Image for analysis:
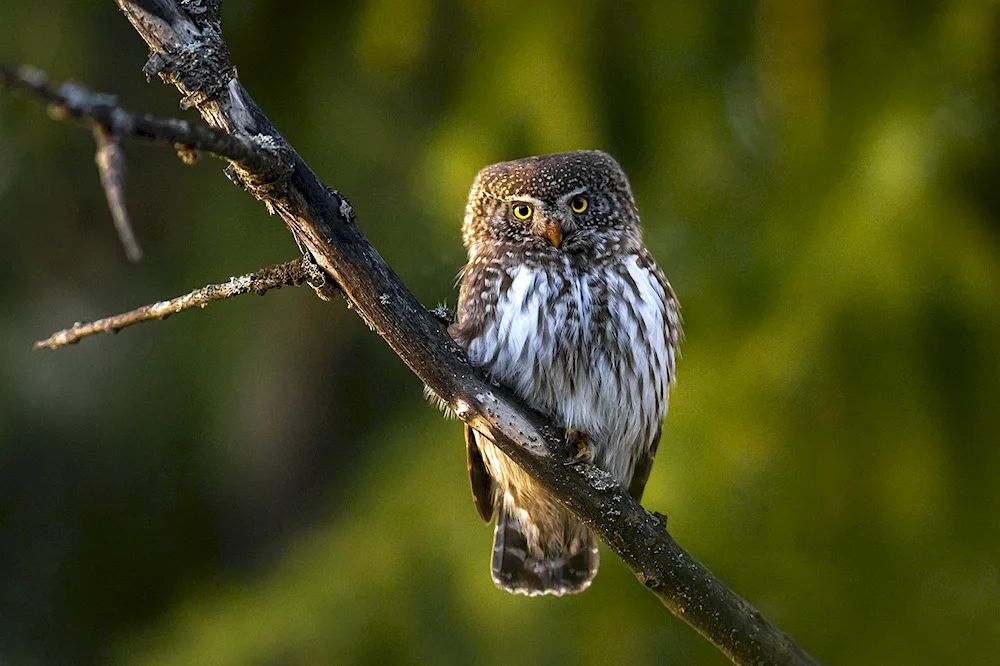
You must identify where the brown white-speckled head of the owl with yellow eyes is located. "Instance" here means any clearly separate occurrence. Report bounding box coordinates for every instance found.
[462,150,641,258]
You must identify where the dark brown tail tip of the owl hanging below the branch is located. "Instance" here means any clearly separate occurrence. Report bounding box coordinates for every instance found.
[492,507,600,597]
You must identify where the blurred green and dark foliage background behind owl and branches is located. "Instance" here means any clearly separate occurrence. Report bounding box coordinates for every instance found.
[0,0,1000,666]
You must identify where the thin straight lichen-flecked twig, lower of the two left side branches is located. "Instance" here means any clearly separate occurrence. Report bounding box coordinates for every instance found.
[35,259,324,349]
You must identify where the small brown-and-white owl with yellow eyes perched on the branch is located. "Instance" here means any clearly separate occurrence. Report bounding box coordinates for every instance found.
[449,151,681,596]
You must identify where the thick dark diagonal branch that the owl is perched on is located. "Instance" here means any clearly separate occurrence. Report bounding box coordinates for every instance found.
[5,0,817,664]
